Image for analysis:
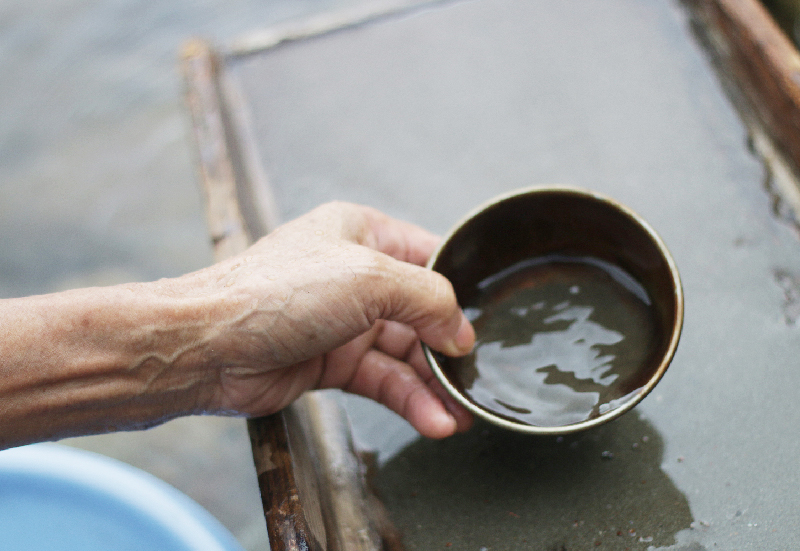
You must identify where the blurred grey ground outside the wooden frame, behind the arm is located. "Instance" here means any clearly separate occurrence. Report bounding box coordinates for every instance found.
[0,0,360,549]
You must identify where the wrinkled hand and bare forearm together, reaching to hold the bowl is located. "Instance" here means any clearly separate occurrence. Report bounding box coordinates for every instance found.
[0,203,475,446]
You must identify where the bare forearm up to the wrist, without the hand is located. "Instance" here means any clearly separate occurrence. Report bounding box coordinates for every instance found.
[0,280,218,447]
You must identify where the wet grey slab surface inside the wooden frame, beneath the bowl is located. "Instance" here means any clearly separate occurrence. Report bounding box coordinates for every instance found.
[223,0,800,551]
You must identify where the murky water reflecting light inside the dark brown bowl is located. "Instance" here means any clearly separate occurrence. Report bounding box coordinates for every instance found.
[451,256,658,426]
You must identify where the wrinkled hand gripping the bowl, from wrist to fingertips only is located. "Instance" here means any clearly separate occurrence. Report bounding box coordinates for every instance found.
[206,203,475,438]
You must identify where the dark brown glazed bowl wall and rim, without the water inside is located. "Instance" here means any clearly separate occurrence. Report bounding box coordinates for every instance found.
[425,187,683,434]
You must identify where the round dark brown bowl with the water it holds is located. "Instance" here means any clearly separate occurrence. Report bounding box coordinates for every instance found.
[425,187,683,434]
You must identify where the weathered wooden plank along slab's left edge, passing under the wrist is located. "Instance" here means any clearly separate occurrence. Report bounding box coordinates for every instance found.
[182,41,388,551]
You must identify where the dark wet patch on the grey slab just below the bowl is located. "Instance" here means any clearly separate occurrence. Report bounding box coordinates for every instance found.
[376,411,702,551]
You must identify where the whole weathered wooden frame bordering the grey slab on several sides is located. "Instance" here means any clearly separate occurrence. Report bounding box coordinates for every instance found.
[182,0,800,551]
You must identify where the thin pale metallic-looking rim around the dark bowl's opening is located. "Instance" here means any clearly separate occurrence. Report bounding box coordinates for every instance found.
[422,185,684,436]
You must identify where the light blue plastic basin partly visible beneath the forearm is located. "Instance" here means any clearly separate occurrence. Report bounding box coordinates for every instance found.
[0,444,242,551]
